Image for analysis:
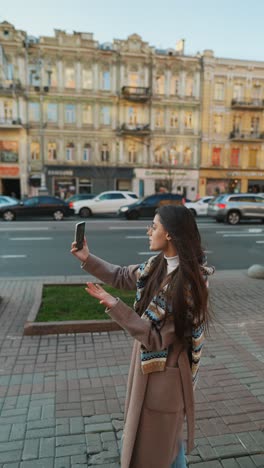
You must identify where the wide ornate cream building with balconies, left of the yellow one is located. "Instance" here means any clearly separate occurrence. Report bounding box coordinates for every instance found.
[0,22,201,198]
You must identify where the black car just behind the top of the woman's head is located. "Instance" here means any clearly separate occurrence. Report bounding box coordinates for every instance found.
[118,193,186,219]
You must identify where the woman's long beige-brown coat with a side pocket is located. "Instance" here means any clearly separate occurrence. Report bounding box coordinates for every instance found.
[82,254,194,468]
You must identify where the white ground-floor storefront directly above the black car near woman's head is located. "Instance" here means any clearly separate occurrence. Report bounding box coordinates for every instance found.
[133,169,199,200]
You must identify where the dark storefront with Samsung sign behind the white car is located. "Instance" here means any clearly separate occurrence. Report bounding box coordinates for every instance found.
[47,166,133,199]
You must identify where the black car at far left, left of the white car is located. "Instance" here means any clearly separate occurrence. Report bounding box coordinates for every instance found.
[0,195,74,221]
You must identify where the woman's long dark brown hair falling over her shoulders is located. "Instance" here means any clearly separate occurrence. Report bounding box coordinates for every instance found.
[137,205,209,342]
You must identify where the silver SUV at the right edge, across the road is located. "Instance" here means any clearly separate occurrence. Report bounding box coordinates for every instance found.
[208,193,264,224]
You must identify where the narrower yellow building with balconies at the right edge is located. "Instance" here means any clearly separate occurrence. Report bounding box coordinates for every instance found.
[199,50,264,196]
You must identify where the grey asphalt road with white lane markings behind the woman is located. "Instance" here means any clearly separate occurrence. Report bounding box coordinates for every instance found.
[0,218,264,277]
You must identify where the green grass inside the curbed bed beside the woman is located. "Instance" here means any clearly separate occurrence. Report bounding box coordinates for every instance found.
[36,285,135,322]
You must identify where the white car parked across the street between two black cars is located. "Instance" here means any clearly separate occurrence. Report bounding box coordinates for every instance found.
[69,190,138,218]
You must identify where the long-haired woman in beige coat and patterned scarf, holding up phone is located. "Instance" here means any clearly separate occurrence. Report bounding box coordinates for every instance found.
[71,205,214,468]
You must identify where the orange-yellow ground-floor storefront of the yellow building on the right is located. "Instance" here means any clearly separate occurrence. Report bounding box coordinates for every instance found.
[199,169,264,196]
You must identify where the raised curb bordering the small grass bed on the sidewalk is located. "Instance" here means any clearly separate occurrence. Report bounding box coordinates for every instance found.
[23,281,122,336]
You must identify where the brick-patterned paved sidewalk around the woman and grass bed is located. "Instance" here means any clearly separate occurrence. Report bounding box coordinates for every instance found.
[0,272,264,468]
